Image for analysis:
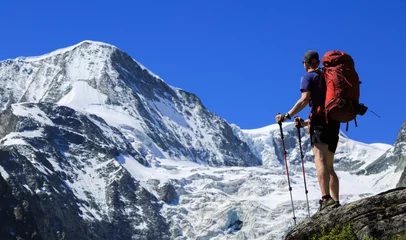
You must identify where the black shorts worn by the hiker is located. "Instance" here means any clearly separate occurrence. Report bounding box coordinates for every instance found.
[310,117,340,153]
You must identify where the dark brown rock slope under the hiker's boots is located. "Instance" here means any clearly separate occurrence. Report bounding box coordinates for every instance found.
[285,188,406,240]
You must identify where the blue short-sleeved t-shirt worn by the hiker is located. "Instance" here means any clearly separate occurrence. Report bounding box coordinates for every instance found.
[300,72,326,107]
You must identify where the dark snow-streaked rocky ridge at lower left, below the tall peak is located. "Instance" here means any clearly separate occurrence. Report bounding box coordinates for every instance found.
[0,103,170,239]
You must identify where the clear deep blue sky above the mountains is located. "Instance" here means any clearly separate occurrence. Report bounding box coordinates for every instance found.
[0,0,406,144]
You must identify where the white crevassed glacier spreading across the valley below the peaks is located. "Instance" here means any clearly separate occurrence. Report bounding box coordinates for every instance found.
[116,153,401,240]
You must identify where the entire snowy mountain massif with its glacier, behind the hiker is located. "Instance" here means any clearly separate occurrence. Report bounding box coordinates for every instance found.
[0,41,401,240]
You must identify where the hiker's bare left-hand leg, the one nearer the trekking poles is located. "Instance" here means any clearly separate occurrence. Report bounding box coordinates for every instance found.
[312,143,330,196]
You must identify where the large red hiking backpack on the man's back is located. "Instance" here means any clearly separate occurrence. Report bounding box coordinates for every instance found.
[321,50,368,130]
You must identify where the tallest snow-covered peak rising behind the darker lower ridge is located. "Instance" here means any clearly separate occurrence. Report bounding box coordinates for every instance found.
[0,41,260,166]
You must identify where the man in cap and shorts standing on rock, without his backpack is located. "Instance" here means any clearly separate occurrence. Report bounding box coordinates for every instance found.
[275,50,340,211]
